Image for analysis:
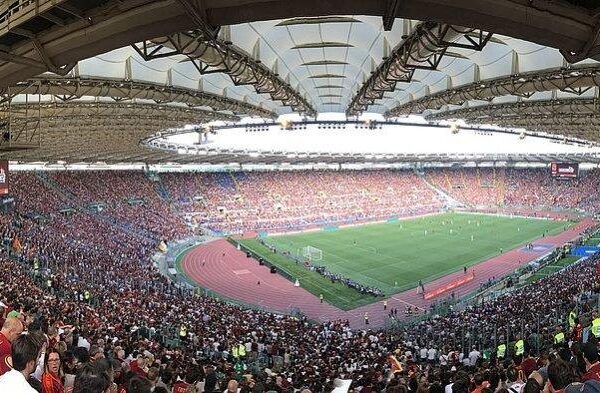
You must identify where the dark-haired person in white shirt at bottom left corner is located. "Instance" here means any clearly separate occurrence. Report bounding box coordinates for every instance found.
[0,334,40,393]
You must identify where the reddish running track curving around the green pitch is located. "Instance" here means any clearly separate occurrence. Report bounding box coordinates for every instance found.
[182,219,595,328]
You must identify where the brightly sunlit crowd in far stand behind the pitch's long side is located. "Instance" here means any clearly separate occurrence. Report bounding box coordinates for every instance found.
[163,170,442,232]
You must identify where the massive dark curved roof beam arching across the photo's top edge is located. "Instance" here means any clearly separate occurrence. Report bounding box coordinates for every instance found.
[0,0,600,93]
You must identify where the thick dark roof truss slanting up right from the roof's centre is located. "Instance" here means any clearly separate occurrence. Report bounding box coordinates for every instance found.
[346,22,492,116]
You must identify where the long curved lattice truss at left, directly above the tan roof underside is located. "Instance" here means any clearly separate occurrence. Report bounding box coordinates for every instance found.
[0,76,277,118]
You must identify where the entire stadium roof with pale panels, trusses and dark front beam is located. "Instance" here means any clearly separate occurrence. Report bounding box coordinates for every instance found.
[0,0,600,162]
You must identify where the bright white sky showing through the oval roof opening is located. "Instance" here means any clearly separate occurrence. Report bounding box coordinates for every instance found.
[146,121,600,163]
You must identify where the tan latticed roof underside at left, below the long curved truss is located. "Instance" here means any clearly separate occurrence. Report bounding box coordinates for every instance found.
[0,99,238,157]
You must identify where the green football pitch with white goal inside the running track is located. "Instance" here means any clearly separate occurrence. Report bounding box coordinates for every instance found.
[241,213,573,310]
